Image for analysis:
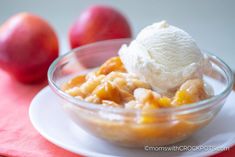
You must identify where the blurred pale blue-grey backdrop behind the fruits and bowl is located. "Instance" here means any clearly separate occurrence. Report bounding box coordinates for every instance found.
[0,0,235,71]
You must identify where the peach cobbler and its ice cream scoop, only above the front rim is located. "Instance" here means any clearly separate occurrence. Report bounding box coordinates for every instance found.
[62,21,210,110]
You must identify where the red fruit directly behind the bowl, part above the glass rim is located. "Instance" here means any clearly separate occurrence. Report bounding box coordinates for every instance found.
[69,5,132,48]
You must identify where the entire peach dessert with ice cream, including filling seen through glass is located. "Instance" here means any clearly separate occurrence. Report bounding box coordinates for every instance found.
[61,21,214,147]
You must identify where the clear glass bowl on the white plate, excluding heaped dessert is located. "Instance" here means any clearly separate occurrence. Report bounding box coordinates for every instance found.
[48,39,233,147]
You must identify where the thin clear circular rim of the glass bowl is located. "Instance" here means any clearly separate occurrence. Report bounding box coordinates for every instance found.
[47,38,234,114]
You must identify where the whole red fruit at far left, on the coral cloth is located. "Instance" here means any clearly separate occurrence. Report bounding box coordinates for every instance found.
[0,13,59,83]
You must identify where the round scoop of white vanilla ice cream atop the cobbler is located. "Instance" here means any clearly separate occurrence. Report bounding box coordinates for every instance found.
[119,21,207,95]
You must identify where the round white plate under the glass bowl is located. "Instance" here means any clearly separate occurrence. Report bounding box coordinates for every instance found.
[29,87,235,157]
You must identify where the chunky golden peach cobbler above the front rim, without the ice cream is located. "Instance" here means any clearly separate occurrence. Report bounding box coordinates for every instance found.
[62,57,209,110]
